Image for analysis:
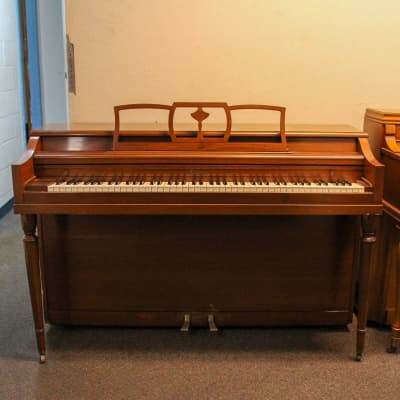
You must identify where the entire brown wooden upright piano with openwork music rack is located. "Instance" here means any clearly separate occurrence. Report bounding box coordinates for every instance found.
[13,102,383,362]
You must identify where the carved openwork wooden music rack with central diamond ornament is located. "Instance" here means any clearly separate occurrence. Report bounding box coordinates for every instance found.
[113,102,287,151]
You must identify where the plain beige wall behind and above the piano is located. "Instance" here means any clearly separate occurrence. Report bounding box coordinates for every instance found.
[66,0,400,127]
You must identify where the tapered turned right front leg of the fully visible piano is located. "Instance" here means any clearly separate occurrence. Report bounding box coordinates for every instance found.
[356,214,378,361]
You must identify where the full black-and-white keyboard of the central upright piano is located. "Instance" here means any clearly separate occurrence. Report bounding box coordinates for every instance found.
[48,178,366,193]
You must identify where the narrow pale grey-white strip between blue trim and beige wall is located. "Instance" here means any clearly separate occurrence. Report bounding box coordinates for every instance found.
[37,0,69,124]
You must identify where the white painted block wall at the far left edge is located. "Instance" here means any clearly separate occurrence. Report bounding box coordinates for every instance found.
[0,0,24,207]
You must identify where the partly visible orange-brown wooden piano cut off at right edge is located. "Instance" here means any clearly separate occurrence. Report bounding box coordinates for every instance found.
[364,109,400,352]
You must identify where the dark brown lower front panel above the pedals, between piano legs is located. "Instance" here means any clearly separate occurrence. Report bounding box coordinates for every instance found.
[40,215,358,326]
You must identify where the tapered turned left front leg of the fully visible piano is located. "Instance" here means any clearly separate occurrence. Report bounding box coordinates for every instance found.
[21,215,46,363]
